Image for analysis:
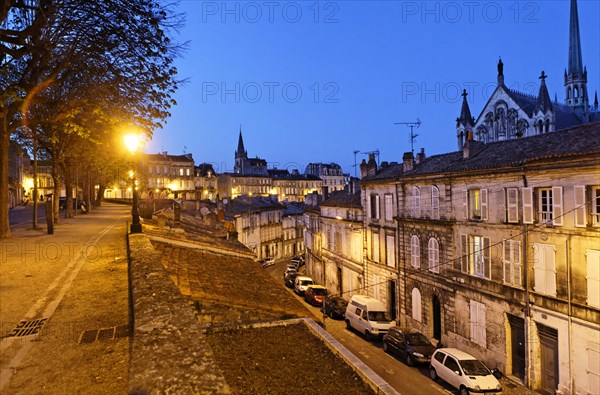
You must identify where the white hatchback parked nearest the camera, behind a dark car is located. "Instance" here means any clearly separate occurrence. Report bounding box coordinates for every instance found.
[429,348,502,395]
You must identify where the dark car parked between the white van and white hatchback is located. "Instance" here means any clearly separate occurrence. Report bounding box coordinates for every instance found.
[383,326,435,366]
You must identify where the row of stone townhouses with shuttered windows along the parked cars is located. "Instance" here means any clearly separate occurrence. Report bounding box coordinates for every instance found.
[306,123,600,394]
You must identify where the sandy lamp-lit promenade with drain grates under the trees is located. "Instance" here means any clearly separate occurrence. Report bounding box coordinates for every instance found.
[0,203,129,394]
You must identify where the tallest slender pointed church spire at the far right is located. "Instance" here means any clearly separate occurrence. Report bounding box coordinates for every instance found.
[565,0,589,117]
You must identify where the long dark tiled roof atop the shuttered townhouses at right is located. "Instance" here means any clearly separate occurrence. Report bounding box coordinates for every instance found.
[361,122,600,182]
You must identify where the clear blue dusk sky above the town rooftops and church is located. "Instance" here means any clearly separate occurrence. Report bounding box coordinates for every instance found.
[146,0,600,175]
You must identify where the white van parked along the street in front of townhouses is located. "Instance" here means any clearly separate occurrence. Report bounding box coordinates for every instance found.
[345,295,396,340]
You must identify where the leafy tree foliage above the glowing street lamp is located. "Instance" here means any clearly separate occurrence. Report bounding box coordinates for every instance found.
[0,0,182,238]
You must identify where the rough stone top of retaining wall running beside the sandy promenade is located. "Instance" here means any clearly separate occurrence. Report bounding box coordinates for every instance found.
[129,234,230,394]
